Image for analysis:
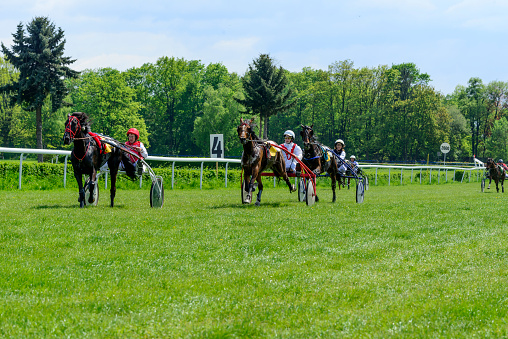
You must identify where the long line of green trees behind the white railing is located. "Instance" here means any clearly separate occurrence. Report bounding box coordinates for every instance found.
[0,18,508,162]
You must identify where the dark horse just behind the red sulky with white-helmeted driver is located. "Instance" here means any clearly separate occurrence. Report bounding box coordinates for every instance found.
[300,125,340,202]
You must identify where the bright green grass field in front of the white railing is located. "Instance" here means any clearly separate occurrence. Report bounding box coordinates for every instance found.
[0,183,508,338]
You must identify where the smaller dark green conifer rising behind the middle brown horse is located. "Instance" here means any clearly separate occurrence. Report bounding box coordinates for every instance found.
[236,54,296,138]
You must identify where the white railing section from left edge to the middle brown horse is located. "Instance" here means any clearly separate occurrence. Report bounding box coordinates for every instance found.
[0,147,240,189]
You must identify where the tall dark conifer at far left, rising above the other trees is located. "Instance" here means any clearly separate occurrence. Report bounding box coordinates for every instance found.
[0,17,79,162]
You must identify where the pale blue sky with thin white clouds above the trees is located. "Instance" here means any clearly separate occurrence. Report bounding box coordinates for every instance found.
[0,0,508,94]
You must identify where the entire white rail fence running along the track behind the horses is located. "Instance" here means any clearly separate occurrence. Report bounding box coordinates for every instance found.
[0,147,484,189]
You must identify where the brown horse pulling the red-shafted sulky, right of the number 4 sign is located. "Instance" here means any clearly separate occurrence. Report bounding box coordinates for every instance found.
[237,119,296,206]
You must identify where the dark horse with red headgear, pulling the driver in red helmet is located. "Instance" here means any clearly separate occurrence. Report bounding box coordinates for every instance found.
[63,112,122,208]
